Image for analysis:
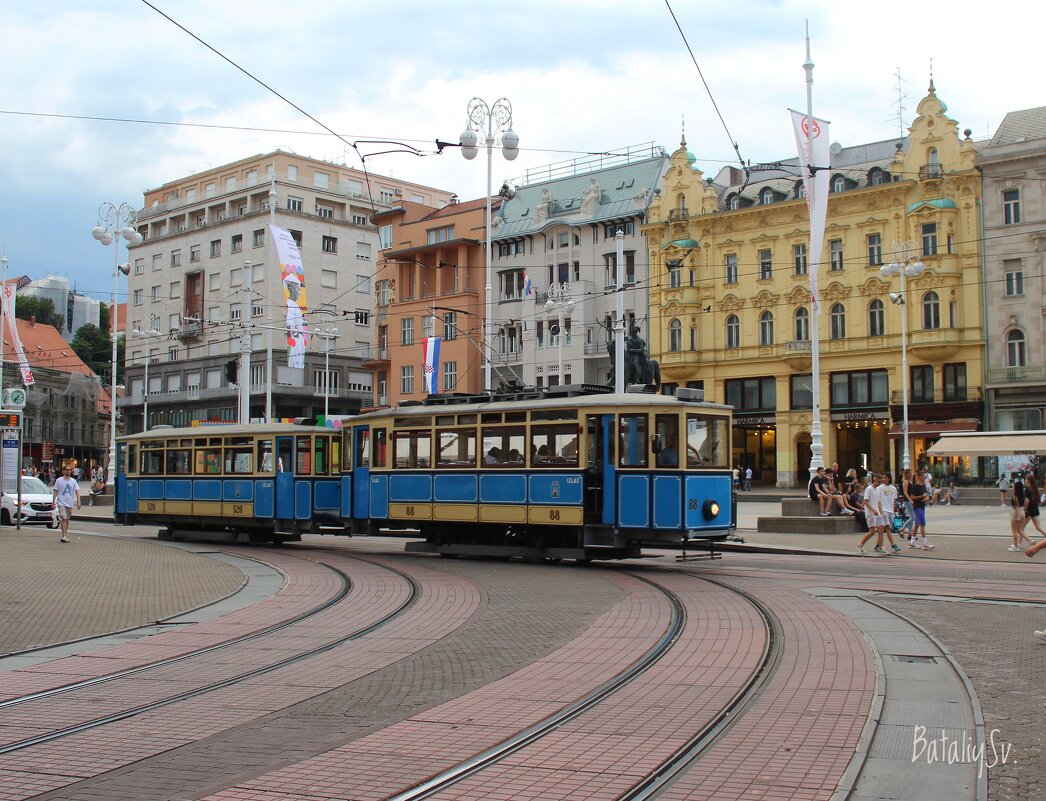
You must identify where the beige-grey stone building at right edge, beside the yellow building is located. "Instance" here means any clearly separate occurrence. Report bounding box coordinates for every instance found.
[981,107,1046,439]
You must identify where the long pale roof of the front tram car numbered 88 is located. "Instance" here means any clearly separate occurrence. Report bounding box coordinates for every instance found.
[353,392,733,422]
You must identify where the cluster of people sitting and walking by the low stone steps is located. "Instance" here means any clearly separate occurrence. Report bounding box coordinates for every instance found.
[809,462,941,555]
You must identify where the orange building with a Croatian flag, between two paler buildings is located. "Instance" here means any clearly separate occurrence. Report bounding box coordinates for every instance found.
[364,198,497,406]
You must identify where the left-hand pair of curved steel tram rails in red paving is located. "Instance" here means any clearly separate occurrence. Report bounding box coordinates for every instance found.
[0,559,422,755]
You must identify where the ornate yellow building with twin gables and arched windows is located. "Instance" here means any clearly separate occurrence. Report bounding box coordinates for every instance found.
[643,82,984,486]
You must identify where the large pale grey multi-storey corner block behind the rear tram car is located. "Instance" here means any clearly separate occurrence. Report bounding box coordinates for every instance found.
[120,151,451,432]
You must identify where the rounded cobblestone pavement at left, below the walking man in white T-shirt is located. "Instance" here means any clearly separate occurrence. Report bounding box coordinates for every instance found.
[0,531,244,654]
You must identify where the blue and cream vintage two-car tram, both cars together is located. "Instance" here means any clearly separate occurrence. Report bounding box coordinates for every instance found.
[116,388,735,559]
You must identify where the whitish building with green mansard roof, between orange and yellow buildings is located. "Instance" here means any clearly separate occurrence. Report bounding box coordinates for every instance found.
[492,145,668,387]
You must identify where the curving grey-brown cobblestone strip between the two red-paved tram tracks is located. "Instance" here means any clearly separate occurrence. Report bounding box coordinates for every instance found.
[38,546,621,801]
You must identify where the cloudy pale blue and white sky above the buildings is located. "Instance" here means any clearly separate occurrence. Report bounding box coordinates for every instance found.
[0,0,1046,300]
